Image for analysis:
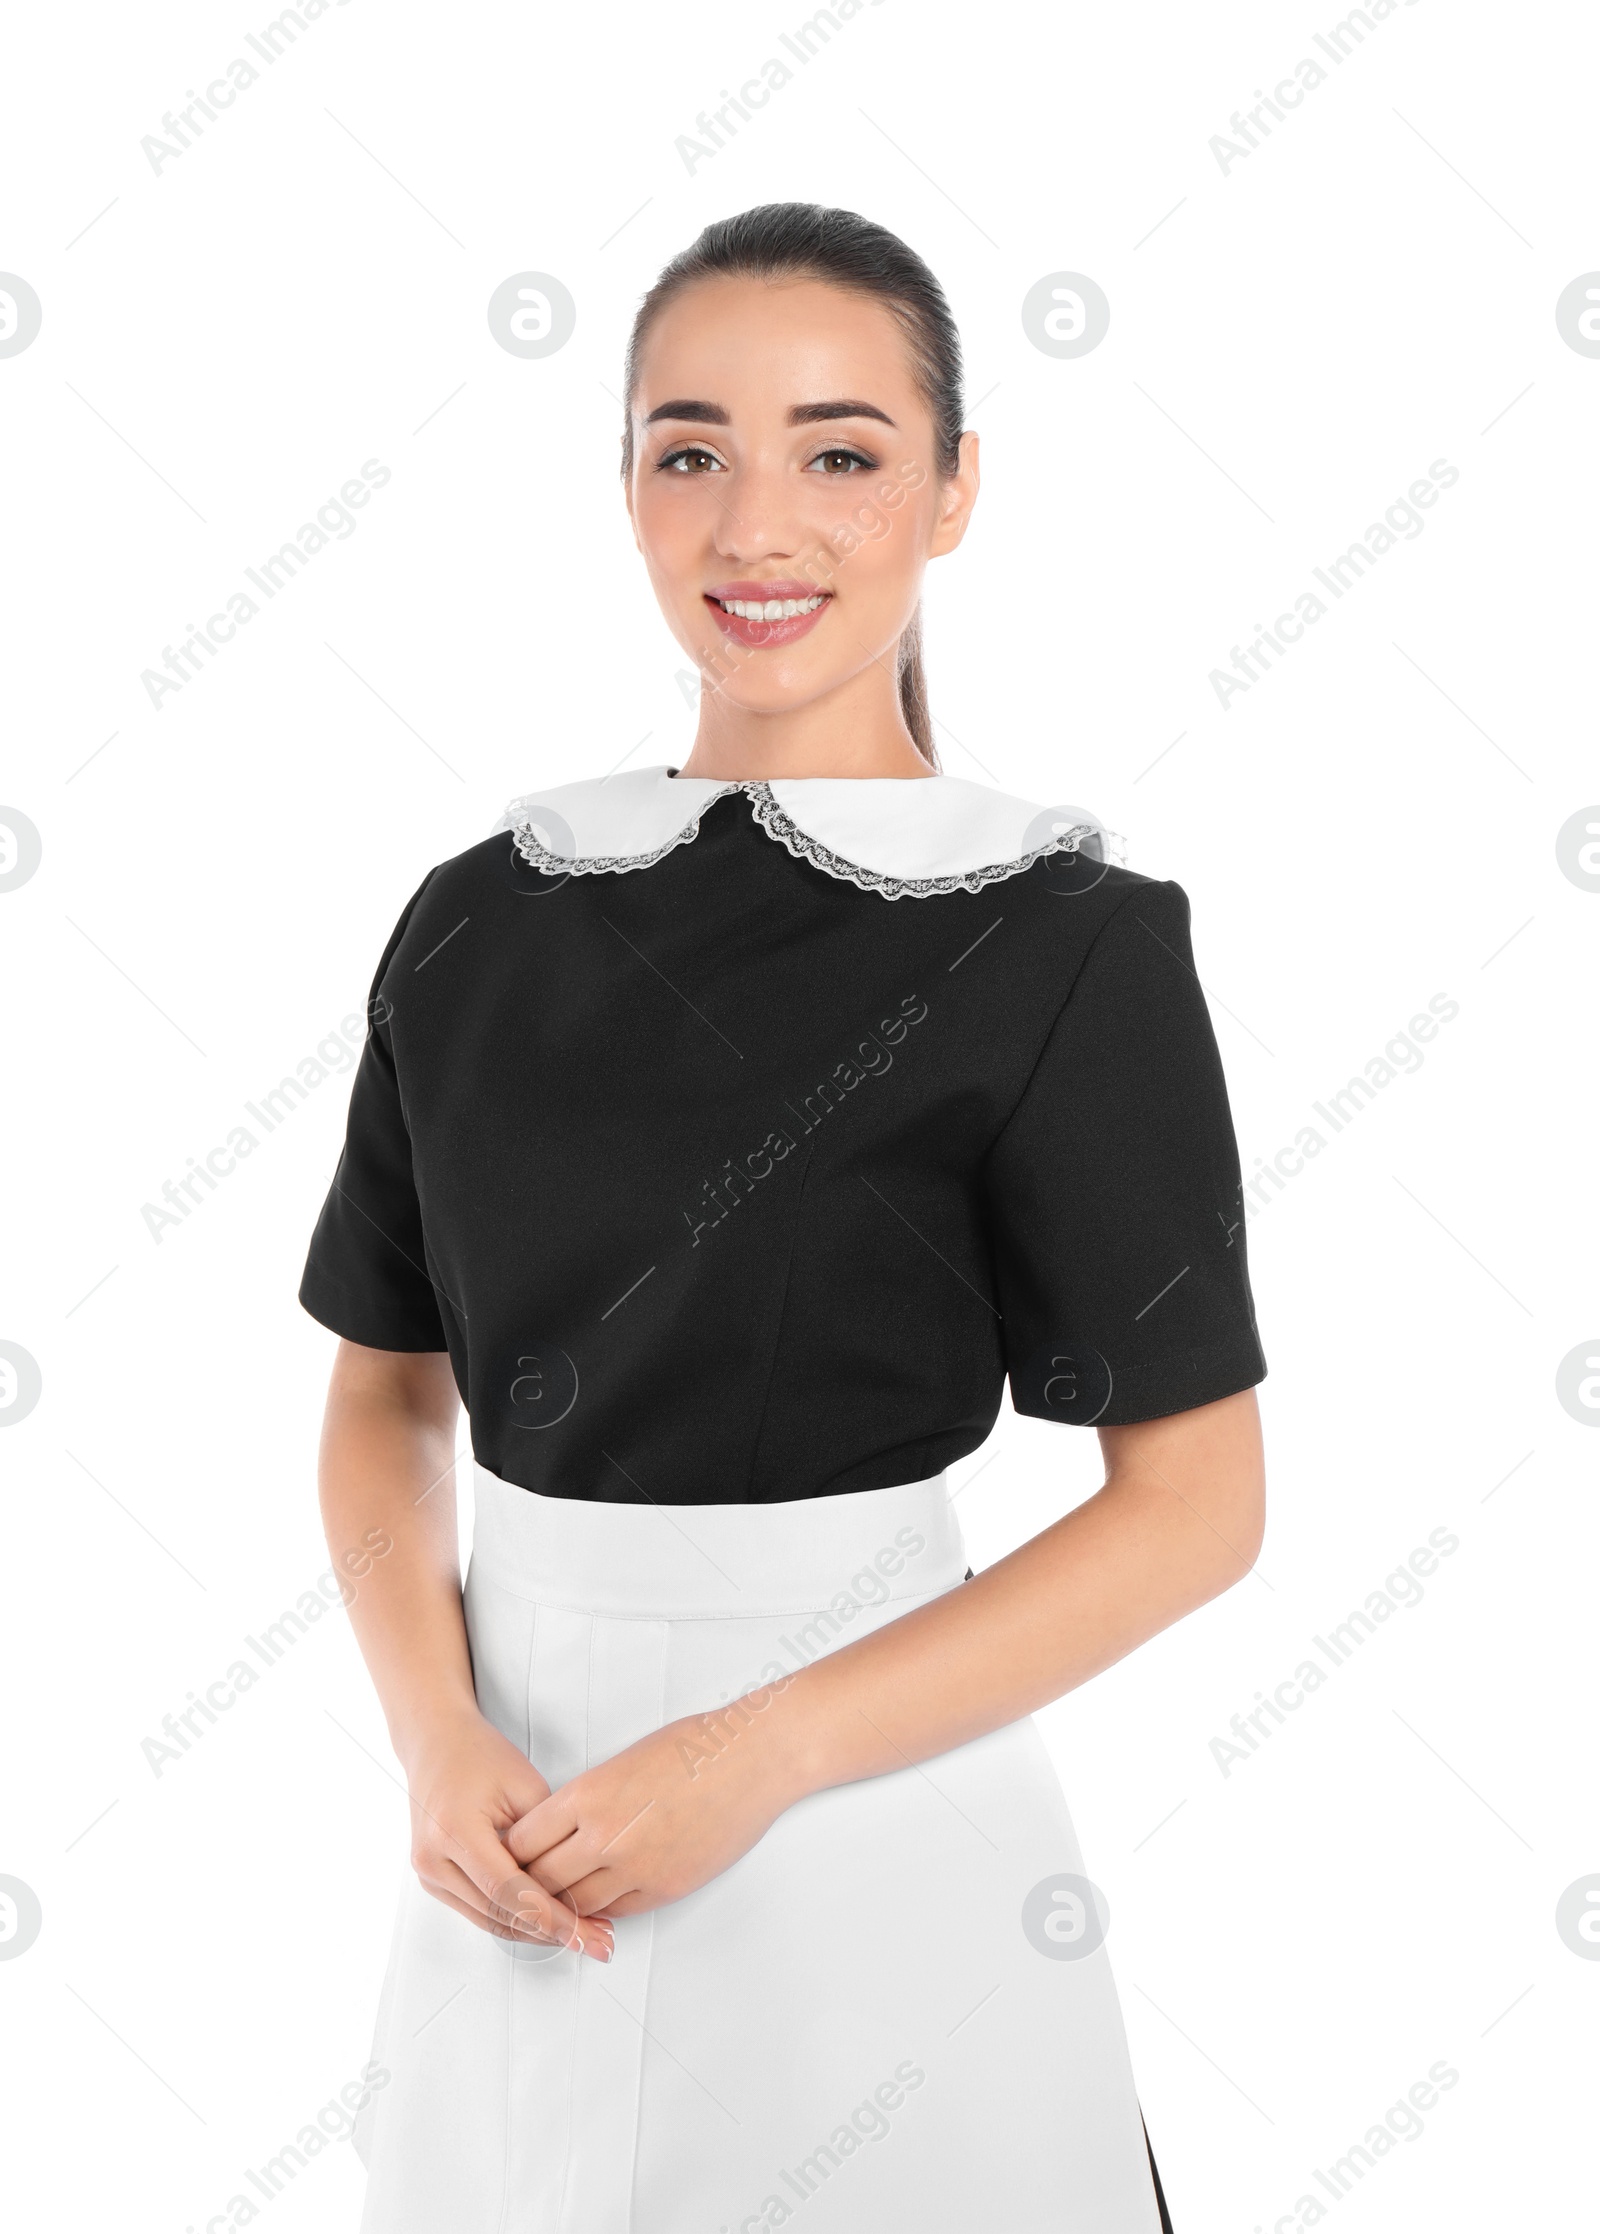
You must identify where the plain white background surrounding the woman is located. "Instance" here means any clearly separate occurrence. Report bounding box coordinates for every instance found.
[0,0,1600,2234]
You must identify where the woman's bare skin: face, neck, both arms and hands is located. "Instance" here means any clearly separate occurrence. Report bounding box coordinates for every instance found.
[320,279,1265,1961]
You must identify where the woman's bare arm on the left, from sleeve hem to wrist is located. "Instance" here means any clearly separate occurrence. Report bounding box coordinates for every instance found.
[320,1343,476,1763]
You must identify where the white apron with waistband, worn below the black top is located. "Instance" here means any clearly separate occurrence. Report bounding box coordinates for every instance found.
[355,1466,1160,2234]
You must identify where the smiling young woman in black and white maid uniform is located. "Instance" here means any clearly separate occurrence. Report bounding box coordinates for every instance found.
[302,203,1265,2234]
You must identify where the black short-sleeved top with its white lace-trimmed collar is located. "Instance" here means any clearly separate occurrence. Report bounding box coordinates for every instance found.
[302,771,1265,1503]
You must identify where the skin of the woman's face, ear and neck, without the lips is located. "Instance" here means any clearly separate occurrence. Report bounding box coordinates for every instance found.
[628,279,979,780]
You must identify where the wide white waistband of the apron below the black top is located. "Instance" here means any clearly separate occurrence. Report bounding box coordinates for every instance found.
[472,1461,968,1620]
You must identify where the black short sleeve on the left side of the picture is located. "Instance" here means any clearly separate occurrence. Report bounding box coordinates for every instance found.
[299,869,449,1349]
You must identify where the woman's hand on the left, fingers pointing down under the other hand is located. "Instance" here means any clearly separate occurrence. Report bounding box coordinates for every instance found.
[404,1709,612,1961]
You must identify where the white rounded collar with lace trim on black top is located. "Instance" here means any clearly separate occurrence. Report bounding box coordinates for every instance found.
[496,766,1124,900]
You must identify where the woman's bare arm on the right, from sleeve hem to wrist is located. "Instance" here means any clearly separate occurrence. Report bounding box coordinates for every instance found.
[751,1394,1260,1798]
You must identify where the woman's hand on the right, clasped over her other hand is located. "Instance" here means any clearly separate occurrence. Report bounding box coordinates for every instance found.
[505,1709,800,1917]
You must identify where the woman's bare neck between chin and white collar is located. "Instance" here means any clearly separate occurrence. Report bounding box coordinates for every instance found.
[677,661,934,784]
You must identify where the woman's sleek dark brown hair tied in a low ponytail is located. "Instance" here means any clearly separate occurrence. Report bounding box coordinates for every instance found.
[621,201,961,768]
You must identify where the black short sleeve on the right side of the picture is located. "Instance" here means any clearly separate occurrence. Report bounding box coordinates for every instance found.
[985,882,1267,1425]
